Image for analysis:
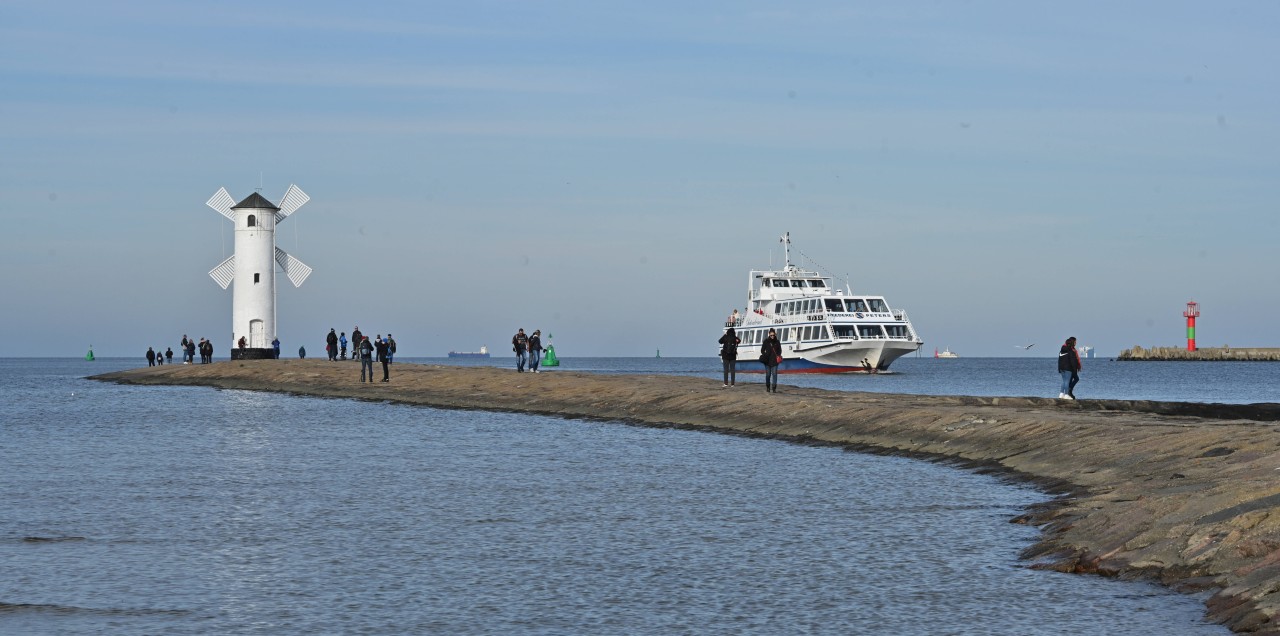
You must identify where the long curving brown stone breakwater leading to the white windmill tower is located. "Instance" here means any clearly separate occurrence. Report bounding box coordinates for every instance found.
[95,360,1280,635]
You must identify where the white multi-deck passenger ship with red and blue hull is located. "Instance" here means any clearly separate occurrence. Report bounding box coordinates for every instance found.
[724,232,924,374]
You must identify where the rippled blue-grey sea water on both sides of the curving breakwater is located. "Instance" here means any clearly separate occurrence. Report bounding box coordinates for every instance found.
[0,357,1280,636]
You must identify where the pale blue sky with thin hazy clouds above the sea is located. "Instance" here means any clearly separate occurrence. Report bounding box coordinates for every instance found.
[0,0,1280,358]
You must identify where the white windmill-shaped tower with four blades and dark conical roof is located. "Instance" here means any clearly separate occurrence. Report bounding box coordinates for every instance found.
[206,184,311,360]
